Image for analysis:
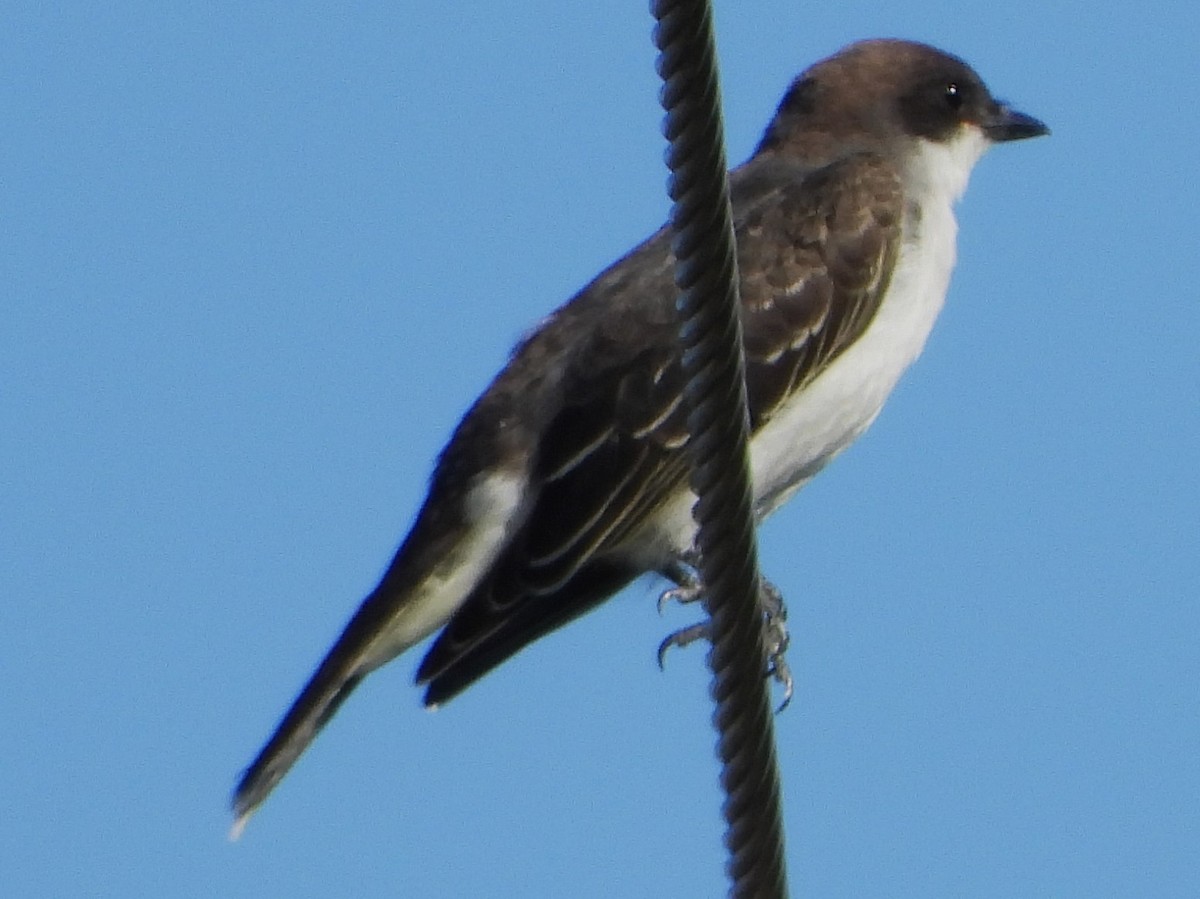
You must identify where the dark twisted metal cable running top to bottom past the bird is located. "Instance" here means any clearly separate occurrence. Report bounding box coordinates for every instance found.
[652,0,787,899]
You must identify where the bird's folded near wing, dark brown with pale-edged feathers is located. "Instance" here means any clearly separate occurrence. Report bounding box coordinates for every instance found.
[418,155,902,703]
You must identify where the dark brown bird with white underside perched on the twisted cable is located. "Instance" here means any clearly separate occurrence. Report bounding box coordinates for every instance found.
[232,38,1049,835]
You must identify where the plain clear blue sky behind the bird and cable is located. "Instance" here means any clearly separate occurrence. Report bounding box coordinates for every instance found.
[0,0,1200,897]
